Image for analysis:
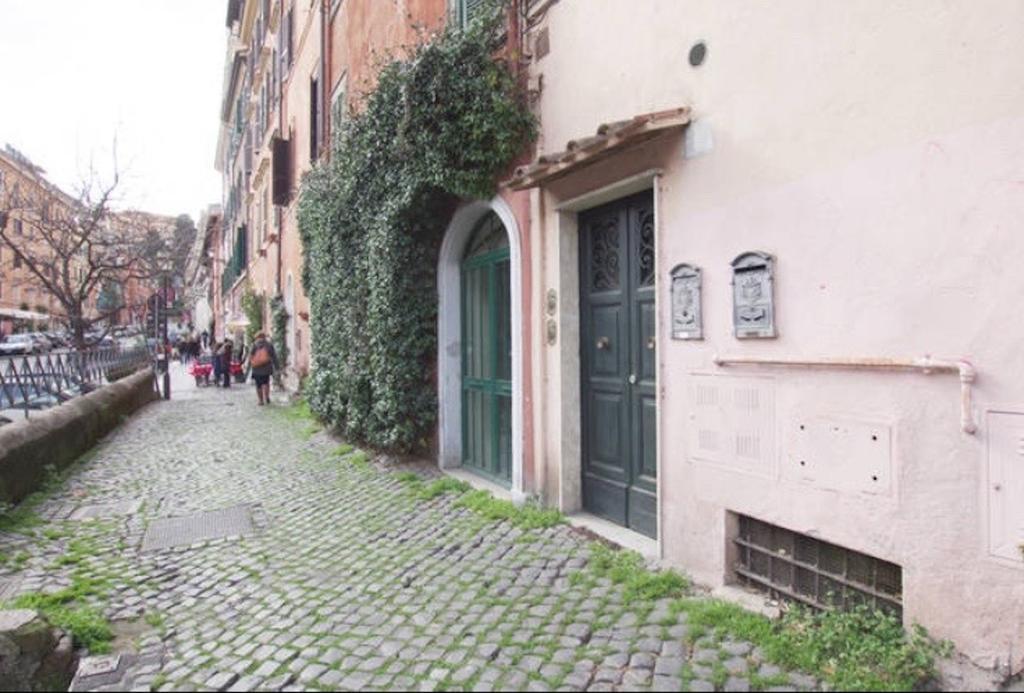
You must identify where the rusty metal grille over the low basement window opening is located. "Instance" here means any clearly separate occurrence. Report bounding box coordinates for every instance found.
[734,515,903,615]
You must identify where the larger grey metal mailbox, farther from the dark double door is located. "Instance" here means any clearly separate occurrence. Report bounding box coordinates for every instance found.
[732,251,775,339]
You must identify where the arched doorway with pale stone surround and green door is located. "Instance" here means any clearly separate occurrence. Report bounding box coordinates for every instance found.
[437,198,525,500]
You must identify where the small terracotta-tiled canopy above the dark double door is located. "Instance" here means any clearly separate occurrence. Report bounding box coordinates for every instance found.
[505,106,690,190]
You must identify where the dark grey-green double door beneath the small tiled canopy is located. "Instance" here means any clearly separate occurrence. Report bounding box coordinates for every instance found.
[580,191,657,536]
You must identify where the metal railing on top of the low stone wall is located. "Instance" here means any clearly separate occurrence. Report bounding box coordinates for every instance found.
[0,347,153,417]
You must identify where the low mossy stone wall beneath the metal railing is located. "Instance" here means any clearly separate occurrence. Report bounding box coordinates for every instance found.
[0,370,158,503]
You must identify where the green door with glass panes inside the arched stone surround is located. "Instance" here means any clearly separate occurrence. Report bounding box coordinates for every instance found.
[462,213,512,486]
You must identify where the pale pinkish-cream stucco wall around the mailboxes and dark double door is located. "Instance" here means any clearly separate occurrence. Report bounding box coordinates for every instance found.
[534,0,1024,668]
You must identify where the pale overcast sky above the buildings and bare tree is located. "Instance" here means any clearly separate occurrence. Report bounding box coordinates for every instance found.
[0,0,226,218]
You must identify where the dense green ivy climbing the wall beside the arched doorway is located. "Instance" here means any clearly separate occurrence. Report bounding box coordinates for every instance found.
[299,8,535,450]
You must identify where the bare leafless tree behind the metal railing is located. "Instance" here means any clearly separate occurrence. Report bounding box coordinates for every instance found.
[0,165,159,349]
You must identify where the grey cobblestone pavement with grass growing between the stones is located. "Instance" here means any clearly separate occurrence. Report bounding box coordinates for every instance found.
[0,364,816,691]
